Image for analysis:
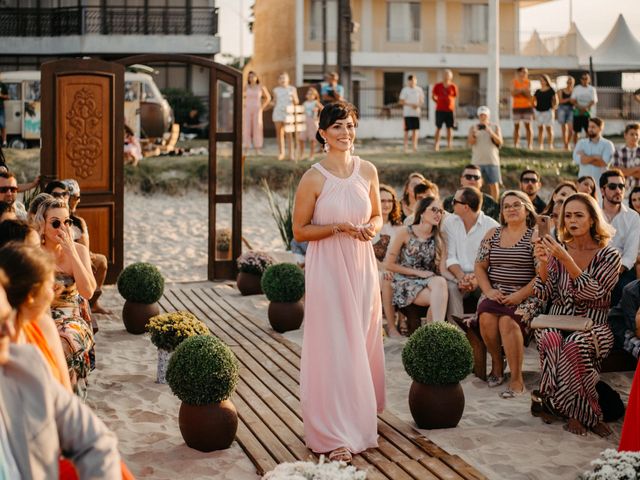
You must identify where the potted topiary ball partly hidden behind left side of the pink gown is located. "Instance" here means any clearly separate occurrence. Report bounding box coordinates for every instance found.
[262,263,304,333]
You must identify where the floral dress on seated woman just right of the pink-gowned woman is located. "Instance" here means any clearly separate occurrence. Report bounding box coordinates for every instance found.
[393,226,436,308]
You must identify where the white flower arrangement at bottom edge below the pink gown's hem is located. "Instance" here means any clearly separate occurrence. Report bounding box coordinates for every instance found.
[262,455,367,480]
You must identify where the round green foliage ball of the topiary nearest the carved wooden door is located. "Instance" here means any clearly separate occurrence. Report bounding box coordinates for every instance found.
[118,262,164,305]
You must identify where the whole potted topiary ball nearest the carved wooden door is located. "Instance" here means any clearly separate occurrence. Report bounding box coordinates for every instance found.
[118,262,164,335]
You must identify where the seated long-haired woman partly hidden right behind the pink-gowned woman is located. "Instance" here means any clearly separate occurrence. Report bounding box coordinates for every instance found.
[378,183,402,337]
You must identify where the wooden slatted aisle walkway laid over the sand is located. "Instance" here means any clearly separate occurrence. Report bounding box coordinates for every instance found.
[160,283,485,480]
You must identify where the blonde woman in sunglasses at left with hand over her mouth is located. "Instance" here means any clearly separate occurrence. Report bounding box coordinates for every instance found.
[35,198,96,397]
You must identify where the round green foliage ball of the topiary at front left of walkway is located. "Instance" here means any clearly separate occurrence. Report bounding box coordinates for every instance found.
[167,335,238,405]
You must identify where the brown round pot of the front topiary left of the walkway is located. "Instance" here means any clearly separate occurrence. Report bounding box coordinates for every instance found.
[178,400,238,452]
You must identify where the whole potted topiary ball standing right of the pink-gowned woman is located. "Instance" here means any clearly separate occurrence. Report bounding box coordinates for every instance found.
[402,322,473,429]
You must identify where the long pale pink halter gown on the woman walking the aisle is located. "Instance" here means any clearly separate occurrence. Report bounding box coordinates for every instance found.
[300,157,385,453]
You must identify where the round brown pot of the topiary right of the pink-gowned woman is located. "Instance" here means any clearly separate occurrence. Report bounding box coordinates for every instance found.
[409,382,464,430]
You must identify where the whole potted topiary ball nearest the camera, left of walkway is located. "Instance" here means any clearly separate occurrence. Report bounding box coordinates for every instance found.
[167,335,238,452]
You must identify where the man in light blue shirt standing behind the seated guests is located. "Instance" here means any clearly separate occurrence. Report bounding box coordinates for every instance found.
[573,117,616,188]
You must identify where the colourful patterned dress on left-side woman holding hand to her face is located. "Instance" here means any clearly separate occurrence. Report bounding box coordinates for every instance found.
[51,272,95,399]
